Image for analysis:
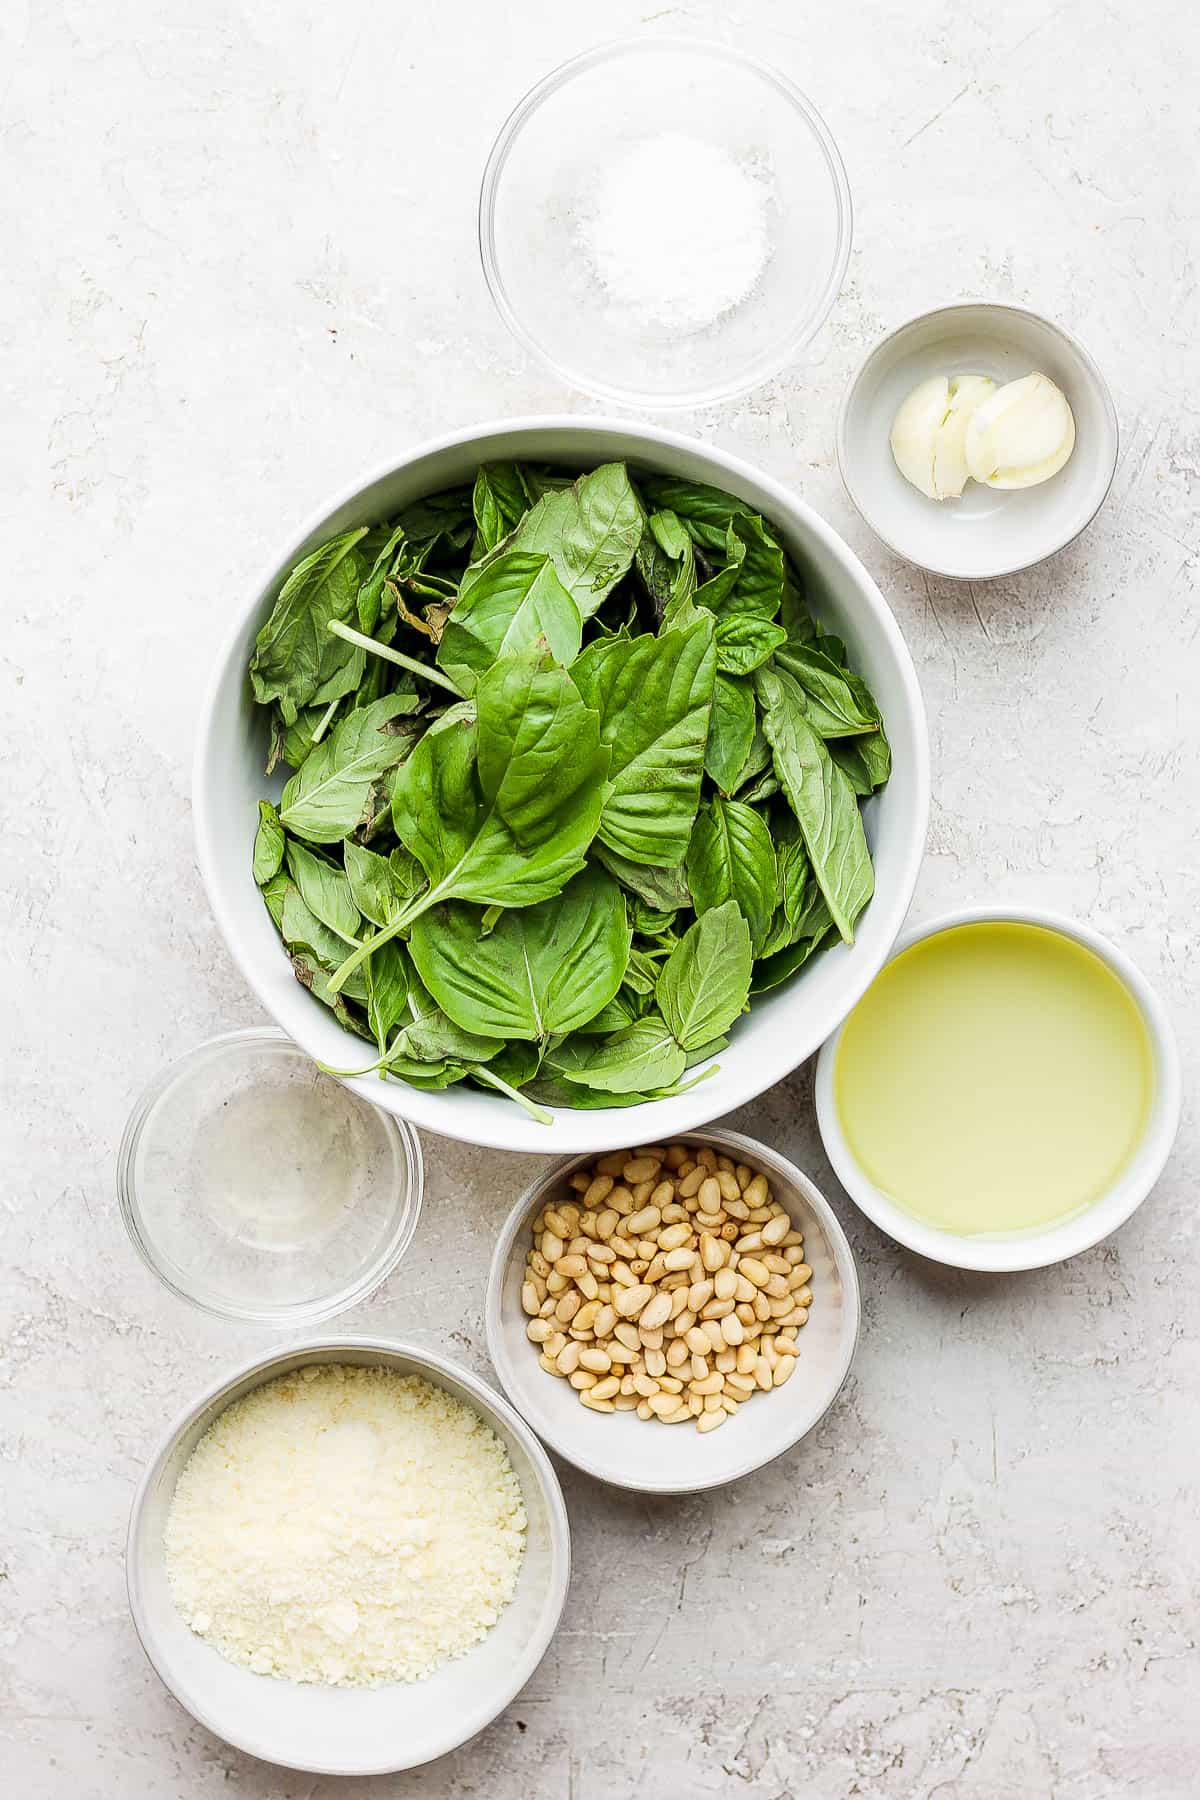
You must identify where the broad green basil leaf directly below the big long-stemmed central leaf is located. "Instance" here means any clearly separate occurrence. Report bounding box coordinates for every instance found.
[410,869,630,1042]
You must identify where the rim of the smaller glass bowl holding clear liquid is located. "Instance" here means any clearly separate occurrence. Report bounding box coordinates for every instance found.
[115,1024,425,1330]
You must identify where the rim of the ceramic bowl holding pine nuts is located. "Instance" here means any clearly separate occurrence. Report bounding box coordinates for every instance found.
[484,1125,862,1496]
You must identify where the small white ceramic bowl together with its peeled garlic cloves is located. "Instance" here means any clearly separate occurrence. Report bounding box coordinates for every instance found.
[837,302,1117,581]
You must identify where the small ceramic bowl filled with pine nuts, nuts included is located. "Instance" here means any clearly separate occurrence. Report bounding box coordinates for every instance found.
[486,1129,860,1494]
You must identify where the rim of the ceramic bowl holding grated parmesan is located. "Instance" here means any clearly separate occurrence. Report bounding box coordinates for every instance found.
[124,1332,570,1775]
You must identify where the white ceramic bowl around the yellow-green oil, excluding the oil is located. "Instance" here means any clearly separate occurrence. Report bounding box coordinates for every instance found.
[815,905,1182,1271]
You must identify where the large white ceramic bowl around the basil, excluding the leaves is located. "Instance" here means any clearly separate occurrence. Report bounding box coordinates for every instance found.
[193,418,928,1154]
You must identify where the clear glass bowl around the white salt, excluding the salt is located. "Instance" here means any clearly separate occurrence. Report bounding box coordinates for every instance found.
[479,38,851,409]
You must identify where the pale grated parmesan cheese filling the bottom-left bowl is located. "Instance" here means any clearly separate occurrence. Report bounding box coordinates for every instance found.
[166,1363,525,1687]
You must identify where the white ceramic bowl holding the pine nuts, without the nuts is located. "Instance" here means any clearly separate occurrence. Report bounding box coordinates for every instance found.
[484,1130,860,1494]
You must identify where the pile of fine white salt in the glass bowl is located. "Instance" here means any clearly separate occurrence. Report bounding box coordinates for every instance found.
[578,131,772,333]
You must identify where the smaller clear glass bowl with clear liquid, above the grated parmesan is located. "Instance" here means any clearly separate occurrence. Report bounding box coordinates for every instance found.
[117,1026,425,1327]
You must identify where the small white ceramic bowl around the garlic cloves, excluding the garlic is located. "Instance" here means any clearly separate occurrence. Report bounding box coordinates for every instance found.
[837,301,1119,581]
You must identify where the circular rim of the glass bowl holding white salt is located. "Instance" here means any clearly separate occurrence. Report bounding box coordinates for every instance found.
[479,32,855,412]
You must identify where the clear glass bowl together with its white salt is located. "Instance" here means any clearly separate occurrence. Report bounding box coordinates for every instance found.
[479,36,851,410]
